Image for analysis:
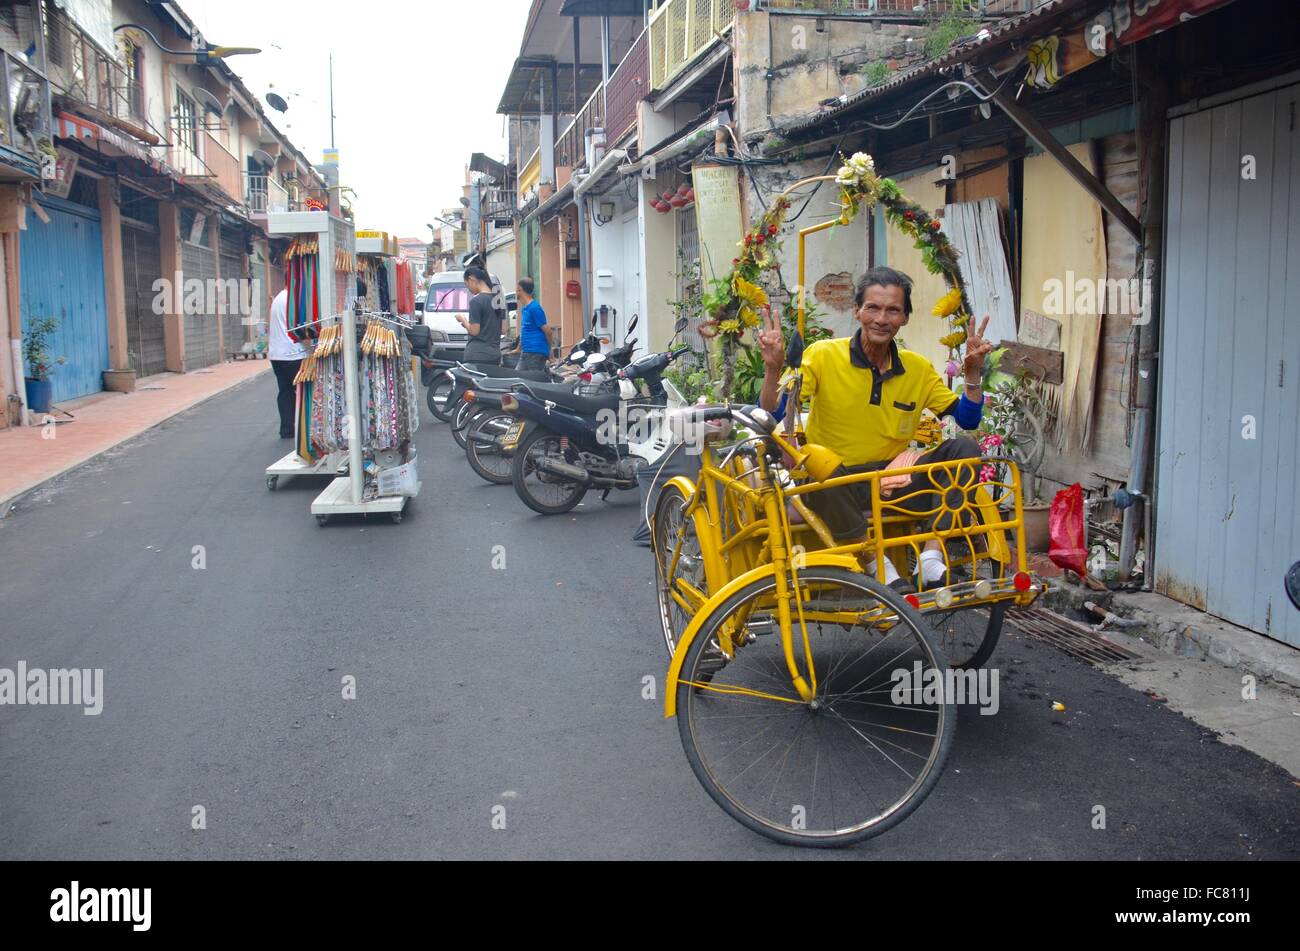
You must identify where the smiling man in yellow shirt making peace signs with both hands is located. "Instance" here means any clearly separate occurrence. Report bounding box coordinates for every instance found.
[759,268,993,590]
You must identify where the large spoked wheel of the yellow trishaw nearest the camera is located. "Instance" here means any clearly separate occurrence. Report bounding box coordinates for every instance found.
[677,566,957,847]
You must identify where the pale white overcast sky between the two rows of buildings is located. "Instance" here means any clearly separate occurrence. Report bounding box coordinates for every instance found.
[181,0,529,240]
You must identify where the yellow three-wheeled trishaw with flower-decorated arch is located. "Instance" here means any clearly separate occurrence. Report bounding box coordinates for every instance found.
[651,163,1043,846]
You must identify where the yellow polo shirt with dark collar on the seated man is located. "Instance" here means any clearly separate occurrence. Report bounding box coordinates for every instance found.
[802,334,958,465]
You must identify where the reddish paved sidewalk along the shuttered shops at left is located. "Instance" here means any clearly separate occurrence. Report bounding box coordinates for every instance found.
[0,360,266,517]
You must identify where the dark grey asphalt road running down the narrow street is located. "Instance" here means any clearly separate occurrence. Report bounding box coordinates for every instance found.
[0,375,1300,859]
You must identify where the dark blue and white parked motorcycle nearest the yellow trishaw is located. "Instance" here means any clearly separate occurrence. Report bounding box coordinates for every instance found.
[499,318,690,514]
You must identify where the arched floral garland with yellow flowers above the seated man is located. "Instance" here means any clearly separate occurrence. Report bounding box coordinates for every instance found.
[699,152,971,394]
